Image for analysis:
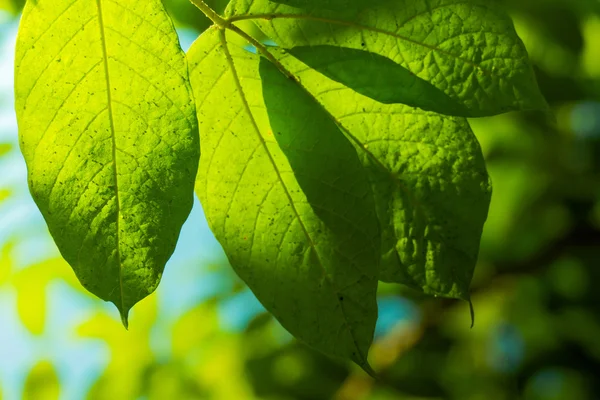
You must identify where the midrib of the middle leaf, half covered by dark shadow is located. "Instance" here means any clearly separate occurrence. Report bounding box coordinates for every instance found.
[219,29,369,368]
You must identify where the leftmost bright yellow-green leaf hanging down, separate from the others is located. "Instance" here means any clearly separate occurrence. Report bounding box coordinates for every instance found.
[15,0,199,324]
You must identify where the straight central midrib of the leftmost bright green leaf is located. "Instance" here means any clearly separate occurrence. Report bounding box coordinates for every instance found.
[96,0,127,320]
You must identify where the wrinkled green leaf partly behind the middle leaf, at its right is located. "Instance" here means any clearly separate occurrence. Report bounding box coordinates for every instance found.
[273,51,491,299]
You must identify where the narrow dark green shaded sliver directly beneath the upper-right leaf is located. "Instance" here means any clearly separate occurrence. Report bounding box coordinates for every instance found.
[289,45,469,116]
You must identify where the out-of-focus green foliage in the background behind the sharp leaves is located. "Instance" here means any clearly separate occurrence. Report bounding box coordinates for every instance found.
[0,0,600,400]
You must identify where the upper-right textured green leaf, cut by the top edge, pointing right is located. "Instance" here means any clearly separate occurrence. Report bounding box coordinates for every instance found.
[225,0,546,117]
